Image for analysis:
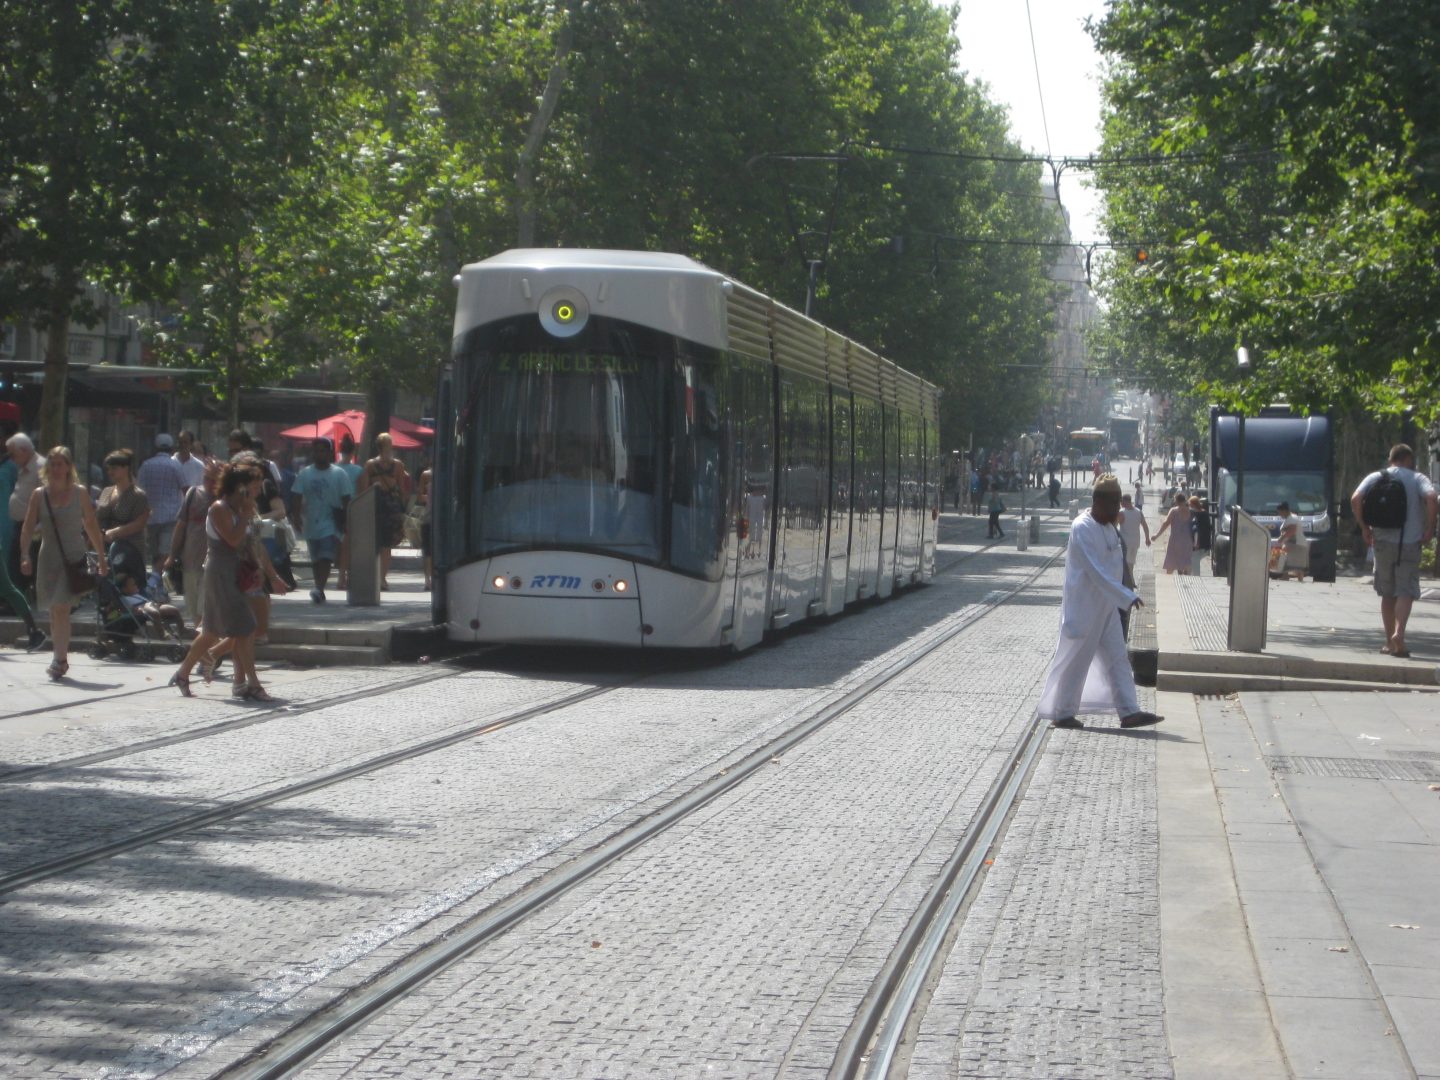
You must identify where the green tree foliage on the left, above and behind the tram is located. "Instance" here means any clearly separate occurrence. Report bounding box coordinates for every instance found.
[0,0,1060,444]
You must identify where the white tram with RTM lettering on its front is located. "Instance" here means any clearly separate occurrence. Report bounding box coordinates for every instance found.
[433,249,940,649]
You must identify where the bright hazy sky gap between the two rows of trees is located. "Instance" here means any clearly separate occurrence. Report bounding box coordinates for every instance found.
[956,0,1104,240]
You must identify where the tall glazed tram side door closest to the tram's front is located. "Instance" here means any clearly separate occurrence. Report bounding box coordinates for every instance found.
[730,356,775,649]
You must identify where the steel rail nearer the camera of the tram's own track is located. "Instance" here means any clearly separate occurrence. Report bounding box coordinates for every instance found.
[0,680,619,896]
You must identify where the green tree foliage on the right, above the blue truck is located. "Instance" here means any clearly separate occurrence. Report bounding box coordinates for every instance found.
[1093,0,1440,420]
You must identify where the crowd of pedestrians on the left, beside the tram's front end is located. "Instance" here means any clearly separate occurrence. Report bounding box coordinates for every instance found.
[0,429,429,701]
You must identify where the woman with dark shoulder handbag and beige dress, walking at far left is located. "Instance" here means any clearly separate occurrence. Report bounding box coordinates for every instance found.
[20,446,109,680]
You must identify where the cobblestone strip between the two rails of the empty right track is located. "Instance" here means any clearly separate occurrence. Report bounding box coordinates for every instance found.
[298,593,1058,1077]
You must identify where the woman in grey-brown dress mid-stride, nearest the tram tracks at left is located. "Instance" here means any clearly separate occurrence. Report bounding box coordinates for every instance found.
[170,462,271,701]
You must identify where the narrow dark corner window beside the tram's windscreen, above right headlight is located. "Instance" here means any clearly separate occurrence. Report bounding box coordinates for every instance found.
[670,356,730,580]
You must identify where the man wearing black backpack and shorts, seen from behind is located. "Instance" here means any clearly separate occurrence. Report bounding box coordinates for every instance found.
[1351,442,1436,660]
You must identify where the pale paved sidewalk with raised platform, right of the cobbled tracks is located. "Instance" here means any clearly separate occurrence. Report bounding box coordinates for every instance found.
[1152,549,1440,1080]
